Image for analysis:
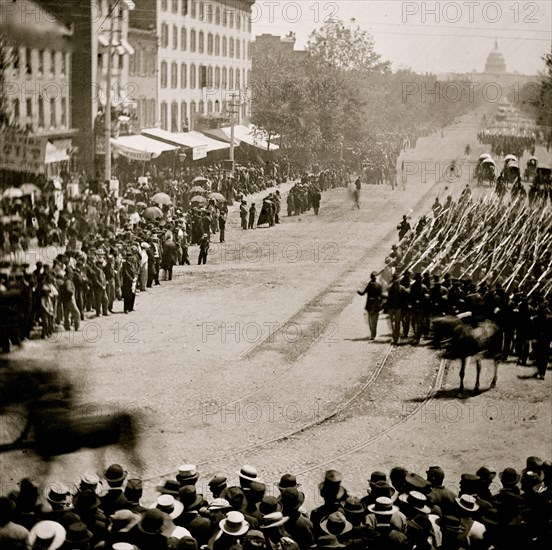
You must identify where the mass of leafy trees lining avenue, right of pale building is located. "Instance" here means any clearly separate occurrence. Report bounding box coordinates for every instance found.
[252,21,486,166]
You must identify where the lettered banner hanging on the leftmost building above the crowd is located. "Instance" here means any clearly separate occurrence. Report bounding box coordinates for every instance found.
[0,128,47,174]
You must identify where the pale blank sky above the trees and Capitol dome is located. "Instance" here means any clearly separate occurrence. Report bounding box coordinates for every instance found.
[252,0,552,75]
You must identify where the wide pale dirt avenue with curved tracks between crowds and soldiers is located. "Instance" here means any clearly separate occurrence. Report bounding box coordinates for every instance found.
[0,113,552,507]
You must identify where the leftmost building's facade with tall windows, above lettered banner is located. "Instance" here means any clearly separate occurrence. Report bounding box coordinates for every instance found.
[0,0,76,176]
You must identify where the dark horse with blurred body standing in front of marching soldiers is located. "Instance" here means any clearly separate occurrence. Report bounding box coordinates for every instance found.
[431,313,500,397]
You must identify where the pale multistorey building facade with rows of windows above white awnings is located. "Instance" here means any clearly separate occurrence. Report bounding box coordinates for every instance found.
[131,0,254,132]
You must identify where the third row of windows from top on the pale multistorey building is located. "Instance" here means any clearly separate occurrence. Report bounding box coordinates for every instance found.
[161,61,251,90]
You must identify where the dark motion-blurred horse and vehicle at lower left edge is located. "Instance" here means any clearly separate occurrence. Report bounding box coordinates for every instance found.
[0,364,143,471]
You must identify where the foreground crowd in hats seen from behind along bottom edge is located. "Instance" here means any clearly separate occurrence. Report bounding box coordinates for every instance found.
[0,456,552,550]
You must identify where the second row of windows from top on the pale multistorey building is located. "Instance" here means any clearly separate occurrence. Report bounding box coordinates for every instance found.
[161,23,251,59]
